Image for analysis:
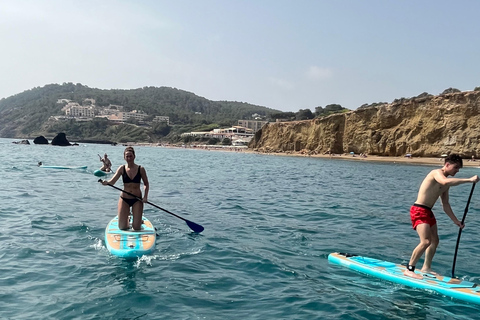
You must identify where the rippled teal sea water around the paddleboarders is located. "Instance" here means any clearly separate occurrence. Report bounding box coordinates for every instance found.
[0,139,480,320]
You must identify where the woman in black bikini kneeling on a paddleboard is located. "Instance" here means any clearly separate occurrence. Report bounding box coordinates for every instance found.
[102,147,149,230]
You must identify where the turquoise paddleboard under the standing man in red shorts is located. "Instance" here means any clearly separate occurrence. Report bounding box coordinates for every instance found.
[328,253,480,304]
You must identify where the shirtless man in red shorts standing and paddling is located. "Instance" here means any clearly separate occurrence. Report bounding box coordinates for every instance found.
[404,154,479,279]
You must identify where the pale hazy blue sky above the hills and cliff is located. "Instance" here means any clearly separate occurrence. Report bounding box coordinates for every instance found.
[0,0,480,112]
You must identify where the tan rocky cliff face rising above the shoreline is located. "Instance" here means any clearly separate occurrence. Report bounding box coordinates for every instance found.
[249,91,480,157]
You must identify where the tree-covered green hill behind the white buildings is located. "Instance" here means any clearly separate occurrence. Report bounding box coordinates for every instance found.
[0,83,279,142]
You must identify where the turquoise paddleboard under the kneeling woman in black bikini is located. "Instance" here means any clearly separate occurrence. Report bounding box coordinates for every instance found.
[105,216,157,258]
